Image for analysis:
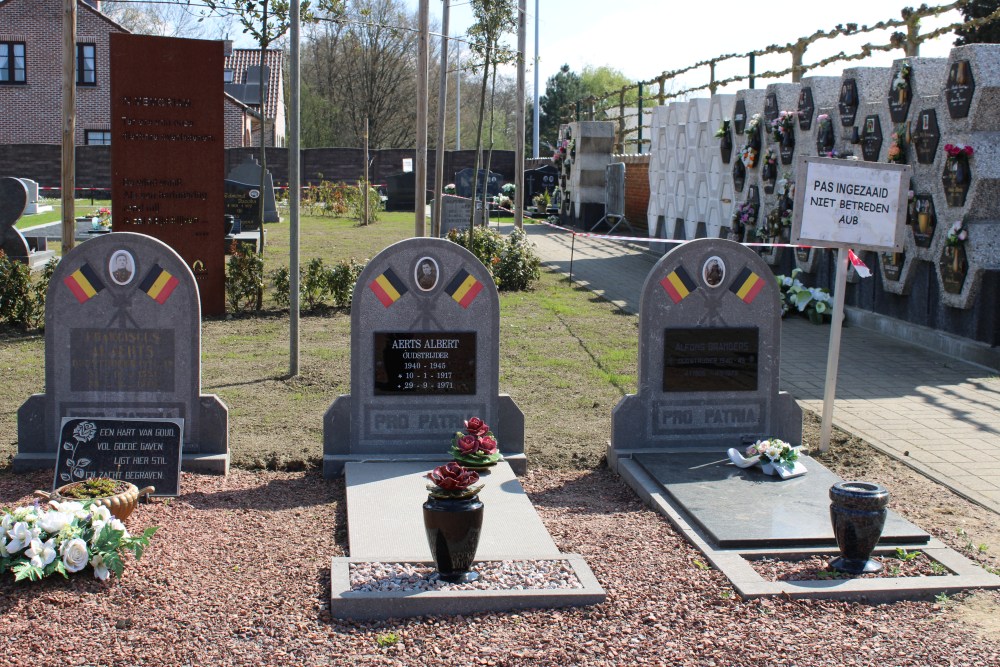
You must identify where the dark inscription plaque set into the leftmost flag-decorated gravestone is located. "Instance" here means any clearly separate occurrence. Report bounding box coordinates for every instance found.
[69,329,174,393]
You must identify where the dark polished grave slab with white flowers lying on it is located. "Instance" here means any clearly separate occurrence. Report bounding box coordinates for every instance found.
[633,452,930,548]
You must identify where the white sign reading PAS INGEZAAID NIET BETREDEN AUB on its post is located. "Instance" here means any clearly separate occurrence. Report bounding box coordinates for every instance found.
[792,157,911,452]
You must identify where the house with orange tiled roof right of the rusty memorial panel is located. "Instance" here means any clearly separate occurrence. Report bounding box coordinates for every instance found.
[223,49,285,147]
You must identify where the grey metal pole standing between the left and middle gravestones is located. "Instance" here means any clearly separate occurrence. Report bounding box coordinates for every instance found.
[290,3,302,377]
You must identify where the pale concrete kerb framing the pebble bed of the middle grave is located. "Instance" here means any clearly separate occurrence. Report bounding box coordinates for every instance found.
[330,554,607,621]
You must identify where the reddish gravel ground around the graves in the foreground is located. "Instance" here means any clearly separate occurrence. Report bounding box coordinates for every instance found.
[0,469,1000,667]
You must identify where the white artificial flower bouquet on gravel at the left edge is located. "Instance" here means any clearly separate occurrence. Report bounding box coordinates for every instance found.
[0,501,158,581]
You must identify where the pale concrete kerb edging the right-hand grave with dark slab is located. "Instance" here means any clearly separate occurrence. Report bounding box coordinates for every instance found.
[608,445,1000,602]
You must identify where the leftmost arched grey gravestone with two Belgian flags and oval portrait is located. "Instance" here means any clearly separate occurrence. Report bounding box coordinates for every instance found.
[13,232,229,473]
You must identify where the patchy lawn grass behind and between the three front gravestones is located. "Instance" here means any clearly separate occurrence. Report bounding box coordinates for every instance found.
[0,213,638,469]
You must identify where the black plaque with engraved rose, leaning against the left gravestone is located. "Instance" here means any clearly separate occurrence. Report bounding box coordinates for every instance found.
[52,417,184,496]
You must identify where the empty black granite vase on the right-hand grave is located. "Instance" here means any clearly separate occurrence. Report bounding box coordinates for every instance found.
[830,482,889,574]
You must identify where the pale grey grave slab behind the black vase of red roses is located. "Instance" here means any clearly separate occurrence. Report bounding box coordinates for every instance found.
[345,459,562,562]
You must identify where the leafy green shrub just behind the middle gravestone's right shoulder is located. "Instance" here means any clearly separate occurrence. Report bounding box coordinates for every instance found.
[448,227,541,292]
